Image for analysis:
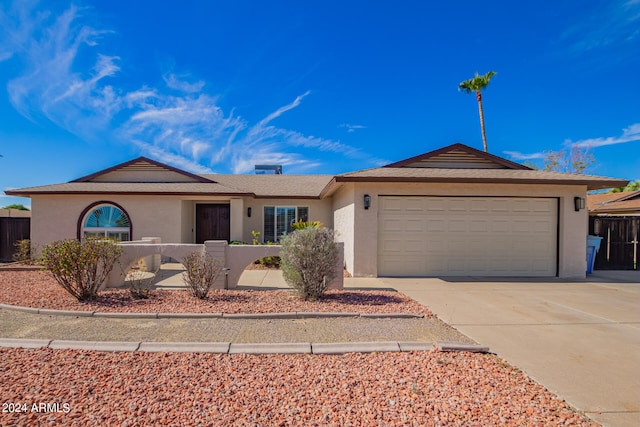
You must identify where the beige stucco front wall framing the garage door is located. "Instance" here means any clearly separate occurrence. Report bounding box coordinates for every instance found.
[345,183,588,278]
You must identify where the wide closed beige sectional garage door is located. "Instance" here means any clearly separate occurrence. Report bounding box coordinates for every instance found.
[378,196,558,276]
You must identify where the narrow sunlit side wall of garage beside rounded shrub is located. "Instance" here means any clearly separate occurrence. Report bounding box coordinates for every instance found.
[333,183,355,274]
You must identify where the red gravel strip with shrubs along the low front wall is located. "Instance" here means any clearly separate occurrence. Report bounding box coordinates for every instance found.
[0,271,433,316]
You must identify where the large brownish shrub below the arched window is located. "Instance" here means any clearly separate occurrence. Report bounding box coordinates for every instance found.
[40,238,123,301]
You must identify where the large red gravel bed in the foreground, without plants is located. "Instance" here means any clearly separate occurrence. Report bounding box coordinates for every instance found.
[0,349,597,426]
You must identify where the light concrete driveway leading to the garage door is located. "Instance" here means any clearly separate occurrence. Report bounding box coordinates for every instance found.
[345,271,640,427]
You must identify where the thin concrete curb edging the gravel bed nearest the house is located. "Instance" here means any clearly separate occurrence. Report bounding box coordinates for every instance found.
[0,303,424,319]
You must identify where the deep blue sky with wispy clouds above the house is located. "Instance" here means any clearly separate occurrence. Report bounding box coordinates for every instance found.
[0,0,640,206]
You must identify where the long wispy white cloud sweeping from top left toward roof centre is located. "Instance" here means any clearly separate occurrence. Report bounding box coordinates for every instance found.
[0,2,384,173]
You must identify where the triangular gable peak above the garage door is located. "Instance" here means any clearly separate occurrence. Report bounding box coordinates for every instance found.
[383,142,531,170]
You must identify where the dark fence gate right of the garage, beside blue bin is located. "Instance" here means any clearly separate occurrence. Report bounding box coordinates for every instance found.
[589,216,640,270]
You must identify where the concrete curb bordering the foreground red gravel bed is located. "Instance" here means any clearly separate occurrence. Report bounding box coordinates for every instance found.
[0,338,489,354]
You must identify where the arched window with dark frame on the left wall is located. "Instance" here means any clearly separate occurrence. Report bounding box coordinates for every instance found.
[80,202,131,241]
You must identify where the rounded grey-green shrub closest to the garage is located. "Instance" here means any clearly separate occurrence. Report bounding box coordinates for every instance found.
[280,227,338,301]
